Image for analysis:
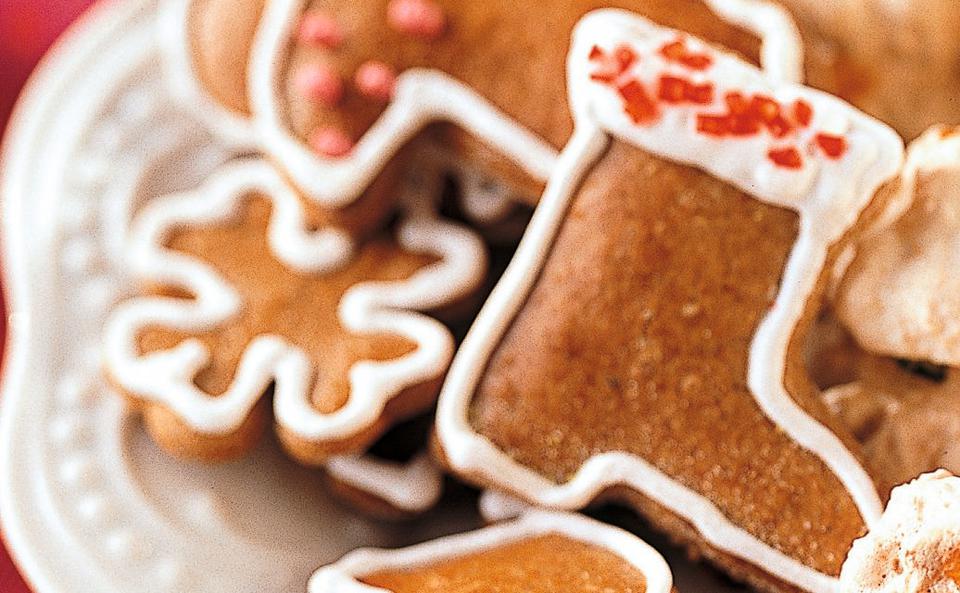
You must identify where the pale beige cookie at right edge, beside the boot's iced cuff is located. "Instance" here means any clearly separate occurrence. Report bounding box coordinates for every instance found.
[836,128,960,366]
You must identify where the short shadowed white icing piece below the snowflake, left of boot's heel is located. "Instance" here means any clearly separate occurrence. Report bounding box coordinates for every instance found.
[324,453,443,513]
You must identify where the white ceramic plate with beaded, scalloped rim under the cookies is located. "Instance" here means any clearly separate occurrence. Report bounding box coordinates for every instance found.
[0,0,734,593]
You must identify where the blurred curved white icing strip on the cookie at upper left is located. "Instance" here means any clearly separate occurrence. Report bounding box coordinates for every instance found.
[157,0,257,152]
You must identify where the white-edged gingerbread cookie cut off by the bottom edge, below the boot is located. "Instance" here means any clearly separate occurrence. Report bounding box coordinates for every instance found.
[309,511,673,593]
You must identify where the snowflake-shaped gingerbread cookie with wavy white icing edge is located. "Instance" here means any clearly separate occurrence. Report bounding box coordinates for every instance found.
[105,161,486,464]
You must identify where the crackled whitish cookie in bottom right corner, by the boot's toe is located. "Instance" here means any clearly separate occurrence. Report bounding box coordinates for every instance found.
[840,471,960,593]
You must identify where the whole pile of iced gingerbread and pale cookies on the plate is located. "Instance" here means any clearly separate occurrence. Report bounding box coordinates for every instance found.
[104,0,960,593]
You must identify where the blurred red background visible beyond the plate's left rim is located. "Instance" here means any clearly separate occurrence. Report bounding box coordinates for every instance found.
[0,0,92,593]
